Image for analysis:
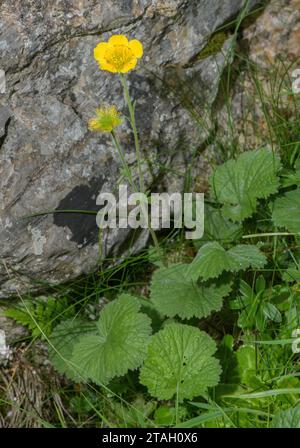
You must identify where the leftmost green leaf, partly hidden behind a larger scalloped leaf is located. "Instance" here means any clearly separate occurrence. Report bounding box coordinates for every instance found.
[49,319,95,382]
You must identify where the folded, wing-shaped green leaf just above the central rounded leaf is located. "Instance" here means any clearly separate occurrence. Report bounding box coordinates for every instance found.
[187,241,267,281]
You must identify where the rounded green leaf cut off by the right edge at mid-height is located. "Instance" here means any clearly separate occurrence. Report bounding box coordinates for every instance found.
[272,188,300,233]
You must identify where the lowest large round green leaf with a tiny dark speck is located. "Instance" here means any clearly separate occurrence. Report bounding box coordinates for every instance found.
[140,324,221,402]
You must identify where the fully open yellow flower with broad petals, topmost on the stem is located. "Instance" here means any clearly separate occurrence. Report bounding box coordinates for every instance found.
[94,34,143,73]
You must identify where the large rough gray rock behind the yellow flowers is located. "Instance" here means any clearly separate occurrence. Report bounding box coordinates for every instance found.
[0,0,258,297]
